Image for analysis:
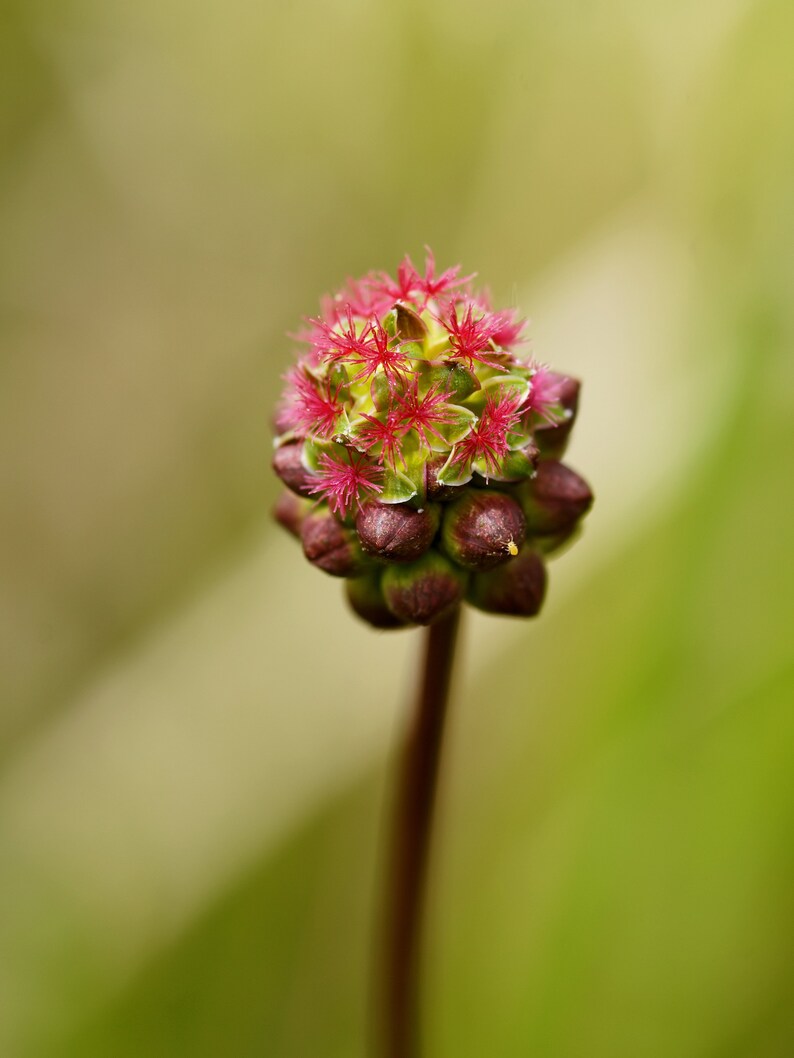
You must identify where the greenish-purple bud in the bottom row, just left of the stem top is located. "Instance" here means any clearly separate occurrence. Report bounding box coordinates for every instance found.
[381,550,468,624]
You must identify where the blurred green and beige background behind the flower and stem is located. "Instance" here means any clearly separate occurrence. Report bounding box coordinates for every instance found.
[0,0,794,1058]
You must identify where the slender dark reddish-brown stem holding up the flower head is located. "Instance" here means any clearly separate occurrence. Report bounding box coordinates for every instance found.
[383,607,459,1058]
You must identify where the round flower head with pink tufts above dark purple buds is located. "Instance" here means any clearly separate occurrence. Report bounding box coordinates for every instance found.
[273,251,593,628]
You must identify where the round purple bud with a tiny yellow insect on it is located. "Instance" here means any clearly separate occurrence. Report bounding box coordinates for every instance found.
[441,489,526,569]
